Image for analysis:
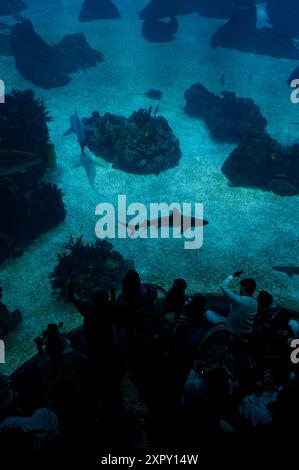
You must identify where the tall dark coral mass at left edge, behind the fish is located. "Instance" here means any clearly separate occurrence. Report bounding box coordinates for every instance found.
[0,90,66,262]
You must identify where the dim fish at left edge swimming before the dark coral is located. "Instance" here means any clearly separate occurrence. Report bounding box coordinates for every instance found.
[0,144,56,176]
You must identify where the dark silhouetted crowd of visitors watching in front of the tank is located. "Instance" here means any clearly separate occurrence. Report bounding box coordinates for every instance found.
[0,270,299,451]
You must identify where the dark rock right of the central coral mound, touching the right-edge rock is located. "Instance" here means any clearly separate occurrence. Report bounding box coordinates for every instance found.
[185,84,267,142]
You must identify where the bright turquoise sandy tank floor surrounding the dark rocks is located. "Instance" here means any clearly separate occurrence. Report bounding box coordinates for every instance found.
[0,0,299,372]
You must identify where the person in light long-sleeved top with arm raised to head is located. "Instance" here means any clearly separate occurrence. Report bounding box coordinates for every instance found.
[206,271,258,338]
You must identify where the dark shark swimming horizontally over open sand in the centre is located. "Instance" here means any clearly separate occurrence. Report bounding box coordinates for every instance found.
[118,209,209,235]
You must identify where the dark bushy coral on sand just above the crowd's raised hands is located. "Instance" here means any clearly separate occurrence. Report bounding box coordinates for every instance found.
[49,236,134,297]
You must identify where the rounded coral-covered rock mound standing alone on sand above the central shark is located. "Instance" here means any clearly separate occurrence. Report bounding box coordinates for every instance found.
[85,107,181,174]
